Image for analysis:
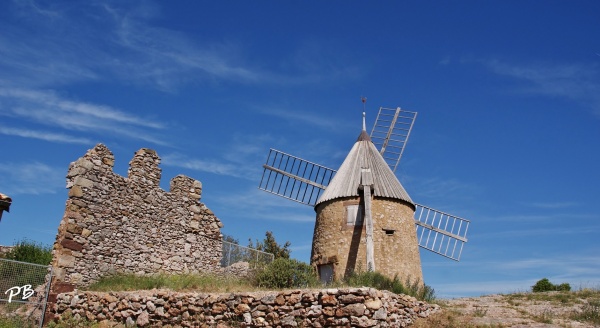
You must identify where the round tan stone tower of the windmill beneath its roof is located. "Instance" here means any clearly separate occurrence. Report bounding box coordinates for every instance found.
[311,197,423,283]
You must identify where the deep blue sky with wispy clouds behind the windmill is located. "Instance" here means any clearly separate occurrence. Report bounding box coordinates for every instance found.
[0,0,600,297]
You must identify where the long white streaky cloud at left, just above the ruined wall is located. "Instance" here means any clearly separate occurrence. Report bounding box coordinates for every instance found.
[0,88,166,144]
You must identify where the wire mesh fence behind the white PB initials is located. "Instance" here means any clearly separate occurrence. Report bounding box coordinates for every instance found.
[0,259,52,327]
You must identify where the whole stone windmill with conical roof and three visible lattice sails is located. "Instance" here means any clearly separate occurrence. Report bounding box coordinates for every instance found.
[259,104,469,282]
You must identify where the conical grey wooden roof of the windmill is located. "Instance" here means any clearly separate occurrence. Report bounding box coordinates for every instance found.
[315,129,414,207]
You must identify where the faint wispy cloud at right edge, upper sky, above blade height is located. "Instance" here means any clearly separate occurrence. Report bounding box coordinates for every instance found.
[483,60,600,117]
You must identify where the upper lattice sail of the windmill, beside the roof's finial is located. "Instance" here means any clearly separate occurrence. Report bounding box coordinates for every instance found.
[371,107,417,172]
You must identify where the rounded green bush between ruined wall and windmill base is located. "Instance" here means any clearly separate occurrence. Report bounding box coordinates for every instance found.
[254,257,319,289]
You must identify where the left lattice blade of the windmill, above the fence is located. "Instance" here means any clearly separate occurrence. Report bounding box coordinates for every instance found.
[258,148,336,206]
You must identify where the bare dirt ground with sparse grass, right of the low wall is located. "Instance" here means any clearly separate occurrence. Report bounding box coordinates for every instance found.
[413,293,600,328]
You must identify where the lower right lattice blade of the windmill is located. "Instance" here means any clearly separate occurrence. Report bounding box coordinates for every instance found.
[415,204,470,261]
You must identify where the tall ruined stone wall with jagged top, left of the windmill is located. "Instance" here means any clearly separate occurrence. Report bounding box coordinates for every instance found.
[52,144,223,285]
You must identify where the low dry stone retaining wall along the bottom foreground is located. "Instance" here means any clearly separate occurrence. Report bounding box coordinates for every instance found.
[52,288,439,327]
